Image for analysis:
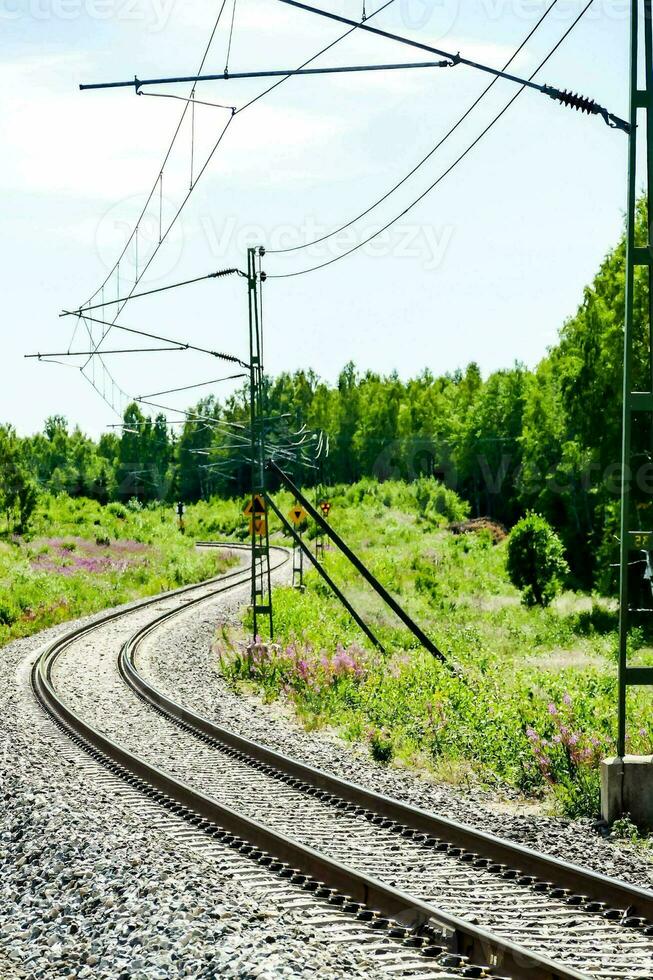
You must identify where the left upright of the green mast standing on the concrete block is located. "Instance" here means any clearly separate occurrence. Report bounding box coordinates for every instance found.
[617,0,650,756]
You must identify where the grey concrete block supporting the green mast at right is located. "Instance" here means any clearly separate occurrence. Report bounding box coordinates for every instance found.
[601,755,653,830]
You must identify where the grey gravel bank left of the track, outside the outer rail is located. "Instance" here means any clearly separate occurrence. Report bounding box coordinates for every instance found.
[0,580,398,980]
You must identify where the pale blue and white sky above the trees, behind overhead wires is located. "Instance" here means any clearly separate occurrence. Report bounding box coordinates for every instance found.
[0,0,629,435]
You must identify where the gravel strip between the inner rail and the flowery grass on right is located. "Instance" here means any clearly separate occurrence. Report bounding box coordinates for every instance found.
[138,580,653,888]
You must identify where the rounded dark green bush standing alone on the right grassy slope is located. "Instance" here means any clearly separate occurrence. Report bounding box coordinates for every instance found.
[507,513,569,606]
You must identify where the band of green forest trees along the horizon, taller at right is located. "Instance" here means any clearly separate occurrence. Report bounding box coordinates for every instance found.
[0,202,653,588]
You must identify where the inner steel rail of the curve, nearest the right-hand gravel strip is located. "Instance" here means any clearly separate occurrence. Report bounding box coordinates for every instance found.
[120,580,653,922]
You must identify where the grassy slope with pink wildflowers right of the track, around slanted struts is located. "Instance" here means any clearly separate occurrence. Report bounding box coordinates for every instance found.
[218,481,653,817]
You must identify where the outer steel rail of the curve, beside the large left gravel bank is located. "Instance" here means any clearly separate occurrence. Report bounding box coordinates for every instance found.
[32,549,588,980]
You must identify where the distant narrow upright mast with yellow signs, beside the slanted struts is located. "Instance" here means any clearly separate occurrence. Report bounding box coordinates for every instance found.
[247,248,273,639]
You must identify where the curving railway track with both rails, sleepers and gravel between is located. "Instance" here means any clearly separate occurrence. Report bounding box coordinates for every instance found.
[32,546,653,980]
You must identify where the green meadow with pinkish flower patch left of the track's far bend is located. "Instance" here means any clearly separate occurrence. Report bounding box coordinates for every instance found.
[0,495,235,646]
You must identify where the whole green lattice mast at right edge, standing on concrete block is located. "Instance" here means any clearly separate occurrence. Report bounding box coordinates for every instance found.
[617,0,653,757]
